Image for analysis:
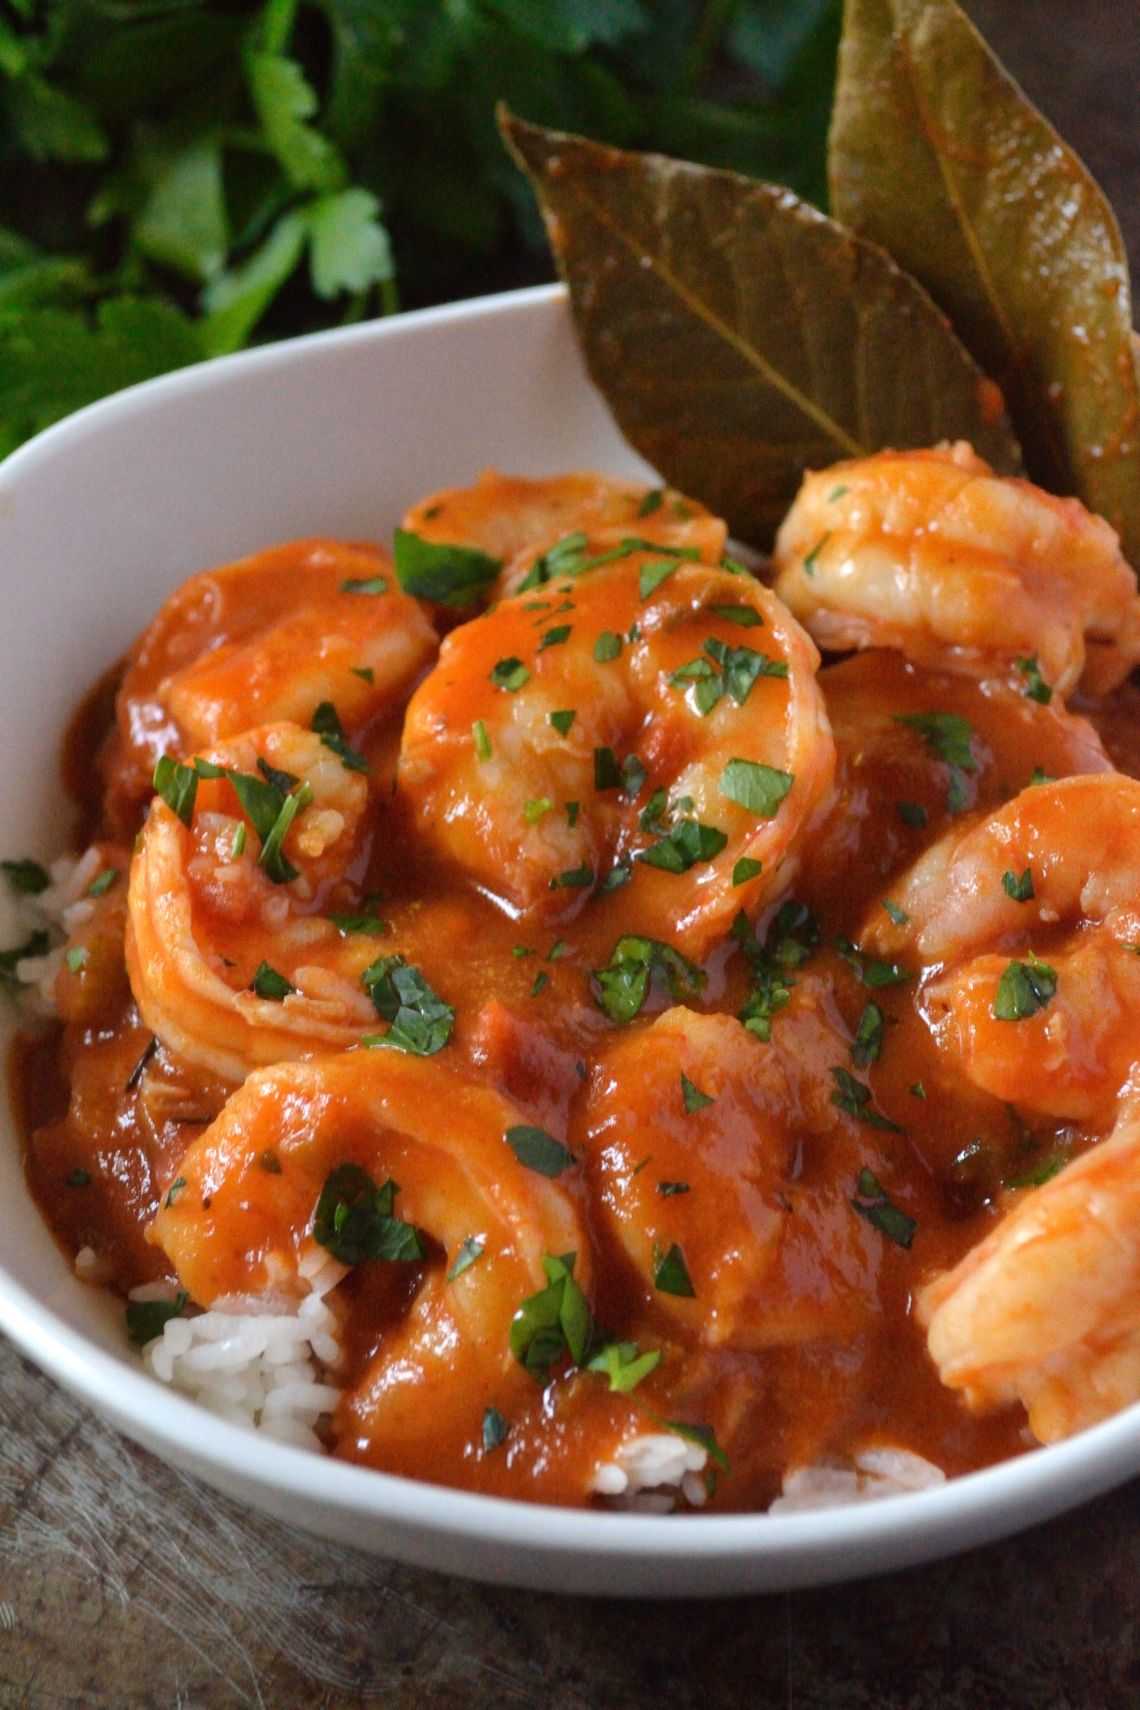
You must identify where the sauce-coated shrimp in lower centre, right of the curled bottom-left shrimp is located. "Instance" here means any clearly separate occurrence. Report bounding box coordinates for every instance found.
[571,992,882,1349]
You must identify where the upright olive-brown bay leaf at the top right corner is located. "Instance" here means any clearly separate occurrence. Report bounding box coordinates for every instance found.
[831,0,1140,568]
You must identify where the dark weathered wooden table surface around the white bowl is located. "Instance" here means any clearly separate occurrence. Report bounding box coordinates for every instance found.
[0,0,1140,1710]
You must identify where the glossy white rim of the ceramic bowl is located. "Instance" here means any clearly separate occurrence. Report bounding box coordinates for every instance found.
[0,284,1140,1592]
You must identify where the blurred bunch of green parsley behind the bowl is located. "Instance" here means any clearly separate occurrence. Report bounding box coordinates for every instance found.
[0,0,839,453]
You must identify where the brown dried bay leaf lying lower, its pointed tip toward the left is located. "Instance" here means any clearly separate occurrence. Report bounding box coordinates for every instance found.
[501,115,1020,545]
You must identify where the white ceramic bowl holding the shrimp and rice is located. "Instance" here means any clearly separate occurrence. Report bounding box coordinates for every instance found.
[0,287,1140,1595]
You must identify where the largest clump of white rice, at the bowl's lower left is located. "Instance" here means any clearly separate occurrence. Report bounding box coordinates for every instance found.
[130,1247,347,1450]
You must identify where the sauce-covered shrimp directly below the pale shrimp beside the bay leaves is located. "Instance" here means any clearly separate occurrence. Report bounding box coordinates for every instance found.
[798,648,1113,920]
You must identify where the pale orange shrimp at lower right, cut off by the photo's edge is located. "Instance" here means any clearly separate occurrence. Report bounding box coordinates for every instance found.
[918,1084,1140,1443]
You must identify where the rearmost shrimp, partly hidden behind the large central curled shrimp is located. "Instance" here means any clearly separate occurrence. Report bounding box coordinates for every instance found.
[403,470,728,599]
